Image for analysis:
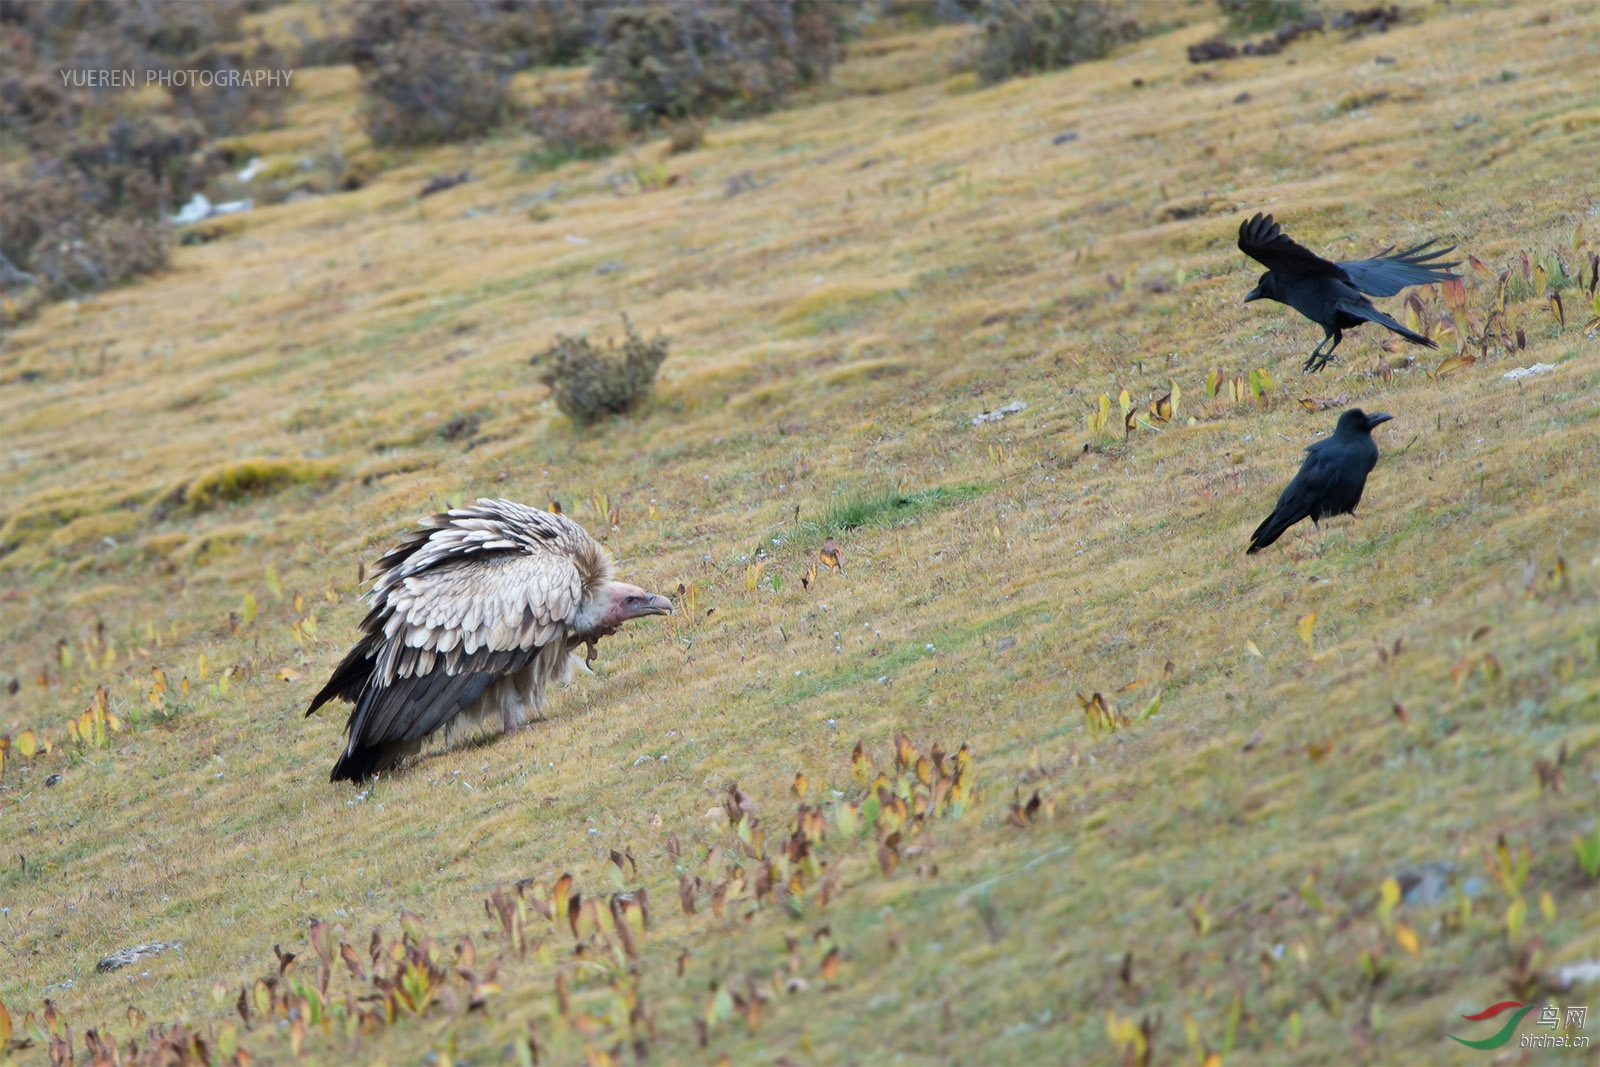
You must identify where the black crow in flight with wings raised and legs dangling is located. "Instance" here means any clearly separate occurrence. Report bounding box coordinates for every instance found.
[1238,214,1458,371]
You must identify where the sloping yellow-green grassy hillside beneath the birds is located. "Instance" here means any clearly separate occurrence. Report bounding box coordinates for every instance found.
[0,3,1600,1064]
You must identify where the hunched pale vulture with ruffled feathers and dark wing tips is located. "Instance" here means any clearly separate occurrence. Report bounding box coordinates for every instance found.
[306,499,672,782]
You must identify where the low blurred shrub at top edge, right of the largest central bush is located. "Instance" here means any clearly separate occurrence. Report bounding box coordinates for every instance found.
[973,0,1139,85]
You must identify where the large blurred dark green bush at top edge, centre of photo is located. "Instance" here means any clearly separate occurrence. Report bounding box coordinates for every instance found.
[592,0,845,130]
